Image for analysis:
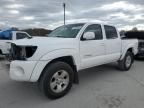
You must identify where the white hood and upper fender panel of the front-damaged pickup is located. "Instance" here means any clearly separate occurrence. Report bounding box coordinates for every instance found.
[11,37,76,60]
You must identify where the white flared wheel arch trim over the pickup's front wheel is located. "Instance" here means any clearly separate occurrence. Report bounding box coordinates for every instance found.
[30,49,80,82]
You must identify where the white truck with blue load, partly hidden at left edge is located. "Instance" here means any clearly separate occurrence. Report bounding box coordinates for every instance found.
[0,31,31,55]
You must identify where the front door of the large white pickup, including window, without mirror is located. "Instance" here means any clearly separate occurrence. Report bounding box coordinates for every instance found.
[80,24,105,68]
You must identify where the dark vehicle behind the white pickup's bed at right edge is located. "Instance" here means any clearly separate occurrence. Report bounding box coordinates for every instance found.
[122,31,144,58]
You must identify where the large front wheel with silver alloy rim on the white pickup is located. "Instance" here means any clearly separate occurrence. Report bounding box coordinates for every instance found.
[39,62,73,99]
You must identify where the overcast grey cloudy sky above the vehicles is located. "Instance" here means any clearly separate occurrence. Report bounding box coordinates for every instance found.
[0,0,144,30]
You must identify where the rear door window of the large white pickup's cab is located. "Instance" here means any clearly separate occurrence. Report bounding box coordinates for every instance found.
[104,25,118,39]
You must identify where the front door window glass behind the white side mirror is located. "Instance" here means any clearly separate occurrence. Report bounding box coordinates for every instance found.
[84,24,103,40]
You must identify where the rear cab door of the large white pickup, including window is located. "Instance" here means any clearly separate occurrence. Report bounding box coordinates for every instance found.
[104,25,121,62]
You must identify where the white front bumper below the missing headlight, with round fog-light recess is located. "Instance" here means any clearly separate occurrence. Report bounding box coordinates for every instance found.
[9,60,37,81]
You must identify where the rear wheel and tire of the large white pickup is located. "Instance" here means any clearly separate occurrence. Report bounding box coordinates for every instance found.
[118,51,134,71]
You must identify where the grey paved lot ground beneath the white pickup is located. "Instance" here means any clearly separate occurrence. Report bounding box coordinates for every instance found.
[0,59,144,108]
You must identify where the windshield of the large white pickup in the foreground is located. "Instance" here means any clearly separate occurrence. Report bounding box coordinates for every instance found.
[48,23,84,38]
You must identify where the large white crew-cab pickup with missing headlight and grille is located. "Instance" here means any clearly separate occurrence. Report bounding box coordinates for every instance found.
[10,23,138,99]
